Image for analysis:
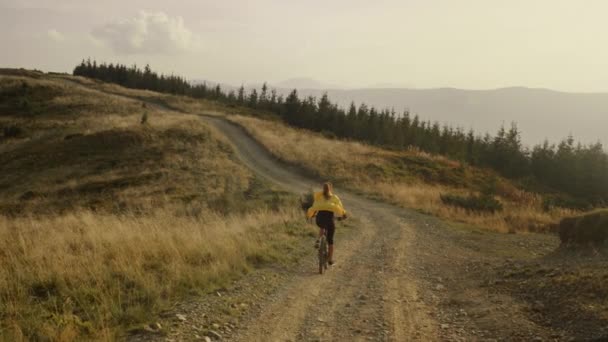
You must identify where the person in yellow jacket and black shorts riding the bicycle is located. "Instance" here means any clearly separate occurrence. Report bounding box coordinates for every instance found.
[306,182,347,265]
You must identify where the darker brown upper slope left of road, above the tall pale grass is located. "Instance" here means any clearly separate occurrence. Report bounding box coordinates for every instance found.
[0,70,290,215]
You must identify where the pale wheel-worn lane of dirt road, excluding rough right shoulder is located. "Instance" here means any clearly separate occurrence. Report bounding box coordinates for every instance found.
[201,118,439,341]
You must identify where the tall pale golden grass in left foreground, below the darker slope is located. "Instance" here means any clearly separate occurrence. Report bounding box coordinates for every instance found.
[0,210,310,341]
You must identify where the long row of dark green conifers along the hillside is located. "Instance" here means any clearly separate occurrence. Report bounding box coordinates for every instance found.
[73,60,608,206]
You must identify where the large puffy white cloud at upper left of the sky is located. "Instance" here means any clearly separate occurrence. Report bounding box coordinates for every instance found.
[91,11,195,54]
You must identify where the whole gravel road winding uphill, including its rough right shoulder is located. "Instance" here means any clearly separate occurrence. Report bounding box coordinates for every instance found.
[59,79,564,341]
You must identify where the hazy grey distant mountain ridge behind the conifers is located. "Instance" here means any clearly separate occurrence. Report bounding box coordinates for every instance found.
[191,79,608,147]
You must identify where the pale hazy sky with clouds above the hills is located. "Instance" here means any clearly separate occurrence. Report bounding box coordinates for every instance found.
[0,0,608,92]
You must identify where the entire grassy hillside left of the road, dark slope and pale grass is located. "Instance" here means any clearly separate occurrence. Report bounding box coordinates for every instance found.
[0,70,310,341]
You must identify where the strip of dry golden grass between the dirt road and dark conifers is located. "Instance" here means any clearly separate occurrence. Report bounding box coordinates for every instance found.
[230,116,573,232]
